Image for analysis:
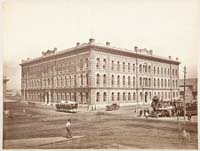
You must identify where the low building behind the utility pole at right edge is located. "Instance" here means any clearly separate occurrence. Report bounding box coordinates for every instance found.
[179,79,198,103]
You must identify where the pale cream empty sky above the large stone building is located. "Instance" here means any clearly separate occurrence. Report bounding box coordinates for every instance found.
[2,0,200,89]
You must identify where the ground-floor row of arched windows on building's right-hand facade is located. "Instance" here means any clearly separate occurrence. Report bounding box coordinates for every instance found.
[96,92,178,102]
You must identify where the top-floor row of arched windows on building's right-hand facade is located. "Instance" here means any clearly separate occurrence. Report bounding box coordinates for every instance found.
[96,58,178,76]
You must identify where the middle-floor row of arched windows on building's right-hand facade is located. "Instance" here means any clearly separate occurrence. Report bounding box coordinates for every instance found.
[96,74,178,88]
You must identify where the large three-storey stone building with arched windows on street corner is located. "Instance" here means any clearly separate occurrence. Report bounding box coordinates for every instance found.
[20,39,180,106]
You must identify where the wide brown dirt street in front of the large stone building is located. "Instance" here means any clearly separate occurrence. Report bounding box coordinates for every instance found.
[3,103,198,149]
